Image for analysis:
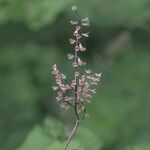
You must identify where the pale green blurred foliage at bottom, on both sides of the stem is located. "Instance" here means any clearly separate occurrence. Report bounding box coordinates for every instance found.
[17,118,102,150]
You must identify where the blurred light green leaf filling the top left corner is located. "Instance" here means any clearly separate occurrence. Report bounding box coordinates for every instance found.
[0,0,69,30]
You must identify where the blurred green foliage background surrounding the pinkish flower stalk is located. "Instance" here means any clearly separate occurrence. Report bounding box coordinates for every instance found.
[0,0,150,150]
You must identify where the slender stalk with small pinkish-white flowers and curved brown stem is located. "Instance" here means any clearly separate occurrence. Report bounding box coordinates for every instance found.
[52,5,101,150]
